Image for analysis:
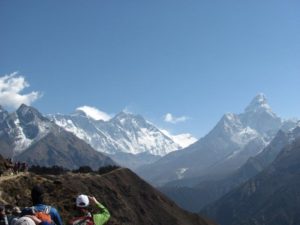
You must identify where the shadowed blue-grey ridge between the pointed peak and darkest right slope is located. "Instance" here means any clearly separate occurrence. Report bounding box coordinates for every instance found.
[160,124,300,212]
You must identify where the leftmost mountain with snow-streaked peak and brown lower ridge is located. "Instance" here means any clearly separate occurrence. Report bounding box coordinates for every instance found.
[0,104,115,169]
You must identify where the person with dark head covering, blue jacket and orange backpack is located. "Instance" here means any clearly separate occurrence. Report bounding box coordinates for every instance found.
[22,185,63,225]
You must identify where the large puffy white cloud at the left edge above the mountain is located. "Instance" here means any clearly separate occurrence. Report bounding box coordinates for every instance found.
[0,72,41,109]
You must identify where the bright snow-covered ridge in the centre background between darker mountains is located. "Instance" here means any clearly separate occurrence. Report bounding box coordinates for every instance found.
[49,108,192,156]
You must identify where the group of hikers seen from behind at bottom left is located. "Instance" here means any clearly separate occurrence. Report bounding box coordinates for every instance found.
[0,185,110,225]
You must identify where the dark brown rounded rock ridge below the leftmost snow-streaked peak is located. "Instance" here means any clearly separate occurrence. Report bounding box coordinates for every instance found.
[16,131,115,170]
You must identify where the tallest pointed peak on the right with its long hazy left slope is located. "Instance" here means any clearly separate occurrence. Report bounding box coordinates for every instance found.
[138,94,295,185]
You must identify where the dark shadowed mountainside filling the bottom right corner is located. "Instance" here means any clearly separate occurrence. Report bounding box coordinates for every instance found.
[204,125,300,225]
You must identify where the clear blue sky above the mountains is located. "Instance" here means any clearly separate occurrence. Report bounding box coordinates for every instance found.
[0,0,300,137]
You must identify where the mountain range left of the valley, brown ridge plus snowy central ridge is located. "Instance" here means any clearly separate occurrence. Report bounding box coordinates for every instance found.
[0,104,195,168]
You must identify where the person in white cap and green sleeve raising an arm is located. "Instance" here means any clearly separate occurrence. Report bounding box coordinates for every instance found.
[69,194,110,225]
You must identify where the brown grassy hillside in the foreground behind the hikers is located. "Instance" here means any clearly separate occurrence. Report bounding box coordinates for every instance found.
[0,169,213,225]
